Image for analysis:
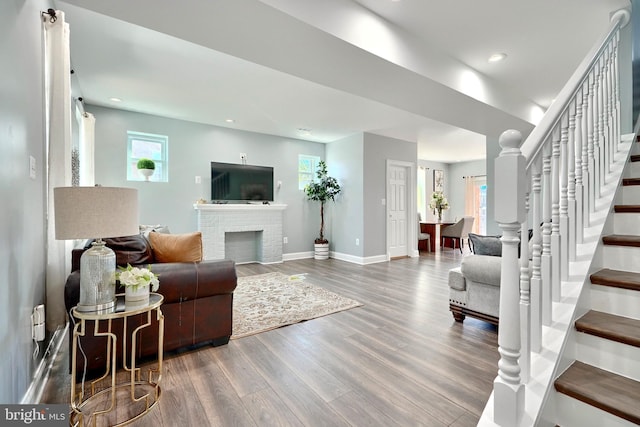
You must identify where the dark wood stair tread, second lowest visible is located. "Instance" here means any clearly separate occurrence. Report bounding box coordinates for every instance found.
[576,310,640,347]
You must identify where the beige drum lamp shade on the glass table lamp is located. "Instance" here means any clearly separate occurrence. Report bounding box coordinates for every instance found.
[53,187,139,240]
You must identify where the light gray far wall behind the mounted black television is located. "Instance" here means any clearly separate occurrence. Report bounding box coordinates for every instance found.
[86,105,325,253]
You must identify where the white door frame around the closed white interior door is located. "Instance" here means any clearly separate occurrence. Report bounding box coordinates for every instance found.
[384,159,419,261]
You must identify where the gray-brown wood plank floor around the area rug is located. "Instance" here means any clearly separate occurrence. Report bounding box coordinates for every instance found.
[43,249,499,427]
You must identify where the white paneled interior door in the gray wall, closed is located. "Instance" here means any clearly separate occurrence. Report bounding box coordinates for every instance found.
[387,164,410,257]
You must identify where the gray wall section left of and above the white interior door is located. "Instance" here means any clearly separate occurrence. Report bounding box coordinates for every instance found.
[363,133,418,258]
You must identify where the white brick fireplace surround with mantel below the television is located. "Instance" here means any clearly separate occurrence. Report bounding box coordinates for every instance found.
[193,203,287,264]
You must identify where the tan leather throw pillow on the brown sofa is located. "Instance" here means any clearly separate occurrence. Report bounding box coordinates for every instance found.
[149,231,202,262]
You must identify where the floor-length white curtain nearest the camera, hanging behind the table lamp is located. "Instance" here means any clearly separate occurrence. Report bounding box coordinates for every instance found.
[42,11,71,331]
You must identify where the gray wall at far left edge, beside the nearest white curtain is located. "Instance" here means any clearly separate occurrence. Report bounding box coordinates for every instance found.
[0,0,51,403]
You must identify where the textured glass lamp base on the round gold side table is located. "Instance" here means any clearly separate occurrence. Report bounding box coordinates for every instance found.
[76,239,116,312]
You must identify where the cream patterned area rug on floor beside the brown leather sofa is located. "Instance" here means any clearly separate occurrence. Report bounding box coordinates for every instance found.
[231,272,362,339]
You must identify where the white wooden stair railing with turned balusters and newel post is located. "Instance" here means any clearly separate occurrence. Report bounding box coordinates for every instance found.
[493,10,630,427]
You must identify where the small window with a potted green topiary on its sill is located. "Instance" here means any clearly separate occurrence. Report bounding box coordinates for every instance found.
[127,131,169,182]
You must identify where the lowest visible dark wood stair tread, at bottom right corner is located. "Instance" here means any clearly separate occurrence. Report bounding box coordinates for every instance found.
[554,361,640,424]
